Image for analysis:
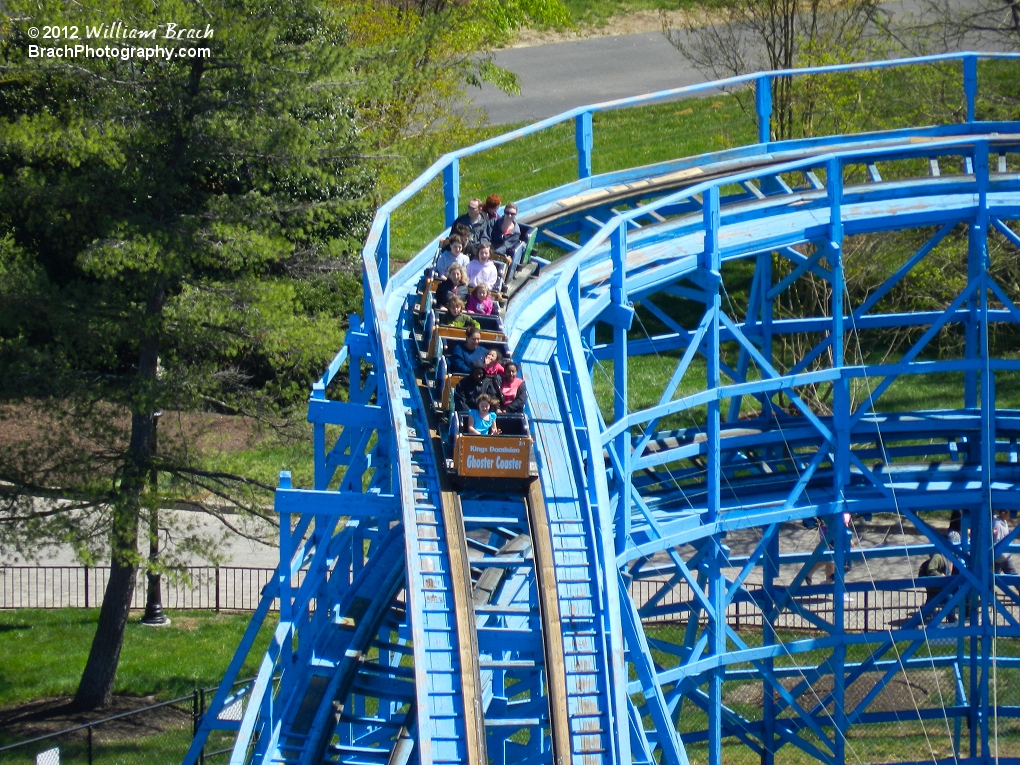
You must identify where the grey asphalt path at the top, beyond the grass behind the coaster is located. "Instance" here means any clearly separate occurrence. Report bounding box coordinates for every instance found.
[467,0,987,124]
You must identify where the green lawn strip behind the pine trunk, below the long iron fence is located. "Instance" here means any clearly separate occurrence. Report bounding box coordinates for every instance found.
[0,609,276,707]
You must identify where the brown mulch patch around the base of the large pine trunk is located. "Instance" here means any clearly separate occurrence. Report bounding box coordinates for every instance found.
[0,696,192,743]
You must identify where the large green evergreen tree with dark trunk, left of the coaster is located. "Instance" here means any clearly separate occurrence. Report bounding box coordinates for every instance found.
[0,0,379,709]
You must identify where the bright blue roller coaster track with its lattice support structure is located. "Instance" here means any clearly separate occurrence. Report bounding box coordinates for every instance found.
[186,53,1020,765]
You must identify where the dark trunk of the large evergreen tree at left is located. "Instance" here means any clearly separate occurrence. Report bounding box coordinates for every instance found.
[72,282,165,711]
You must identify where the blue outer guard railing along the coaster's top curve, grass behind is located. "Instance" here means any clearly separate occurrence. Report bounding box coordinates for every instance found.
[363,51,1020,279]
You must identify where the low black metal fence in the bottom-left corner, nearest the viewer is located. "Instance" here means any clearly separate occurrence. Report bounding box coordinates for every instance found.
[0,679,251,765]
